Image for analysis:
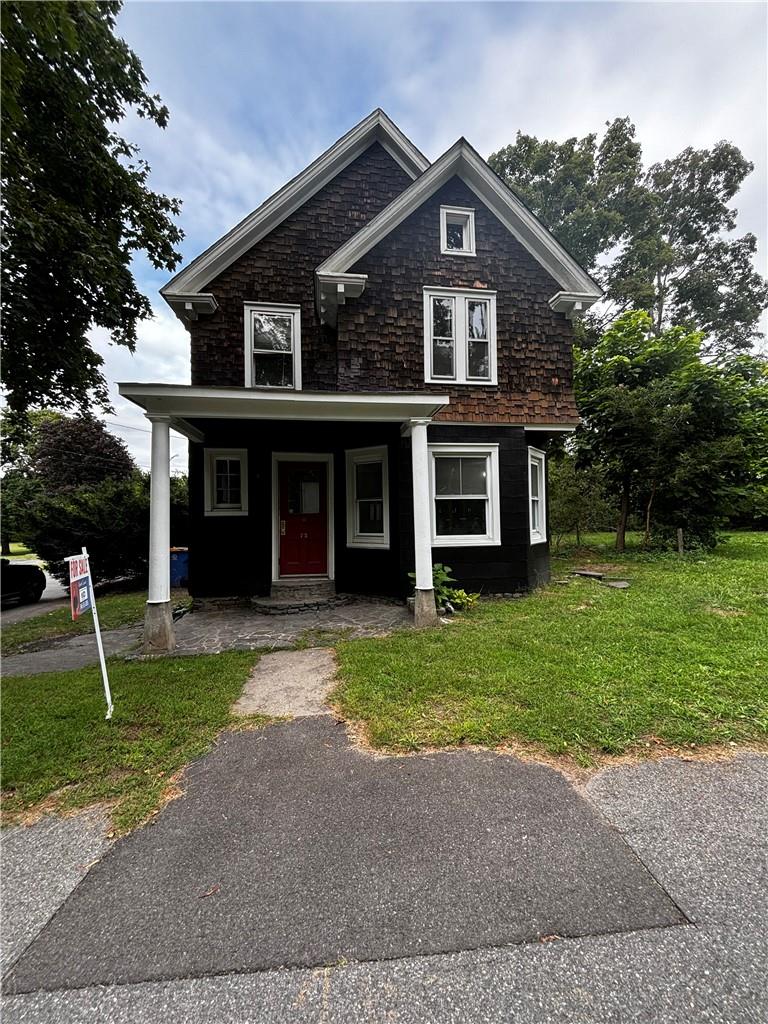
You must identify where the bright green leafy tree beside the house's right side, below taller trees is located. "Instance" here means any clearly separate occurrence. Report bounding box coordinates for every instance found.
[575,311,768,551]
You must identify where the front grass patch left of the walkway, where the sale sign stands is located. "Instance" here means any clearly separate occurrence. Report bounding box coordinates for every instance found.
[2,651,268,833]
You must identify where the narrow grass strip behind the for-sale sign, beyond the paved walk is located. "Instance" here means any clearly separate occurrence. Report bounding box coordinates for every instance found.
[2,591,187,655]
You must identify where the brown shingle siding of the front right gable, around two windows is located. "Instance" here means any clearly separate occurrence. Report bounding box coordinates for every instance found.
[337,177,578,423]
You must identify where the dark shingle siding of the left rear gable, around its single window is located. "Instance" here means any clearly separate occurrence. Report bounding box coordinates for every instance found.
[189,142,411,390]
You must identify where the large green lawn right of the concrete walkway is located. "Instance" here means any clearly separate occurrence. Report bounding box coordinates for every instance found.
[334,534,768,764]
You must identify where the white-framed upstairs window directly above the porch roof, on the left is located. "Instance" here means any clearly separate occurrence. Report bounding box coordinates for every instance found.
[244,302,301,391]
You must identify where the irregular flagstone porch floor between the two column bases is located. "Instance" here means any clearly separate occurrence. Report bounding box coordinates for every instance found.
[175,601,413,654]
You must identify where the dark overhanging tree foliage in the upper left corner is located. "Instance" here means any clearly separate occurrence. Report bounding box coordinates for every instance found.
[1,0,182,414]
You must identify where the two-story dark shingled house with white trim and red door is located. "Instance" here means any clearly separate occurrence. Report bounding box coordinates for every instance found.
[120,110,601,649]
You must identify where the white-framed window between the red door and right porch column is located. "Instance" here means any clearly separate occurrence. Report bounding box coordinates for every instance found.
[346,447,389,548]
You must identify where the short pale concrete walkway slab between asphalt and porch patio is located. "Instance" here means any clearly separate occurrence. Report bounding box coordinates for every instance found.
[232,647,336,717]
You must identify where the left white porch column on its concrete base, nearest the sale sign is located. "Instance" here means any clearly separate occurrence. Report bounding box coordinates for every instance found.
[143,413,175,653]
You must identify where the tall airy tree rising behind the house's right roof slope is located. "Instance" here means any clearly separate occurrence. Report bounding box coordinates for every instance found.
[488,118,768,356]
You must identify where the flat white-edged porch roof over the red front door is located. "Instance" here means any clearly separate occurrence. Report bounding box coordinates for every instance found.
[118,383,450,440]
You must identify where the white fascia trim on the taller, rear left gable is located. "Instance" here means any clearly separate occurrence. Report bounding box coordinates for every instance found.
[160,110,429,302]
